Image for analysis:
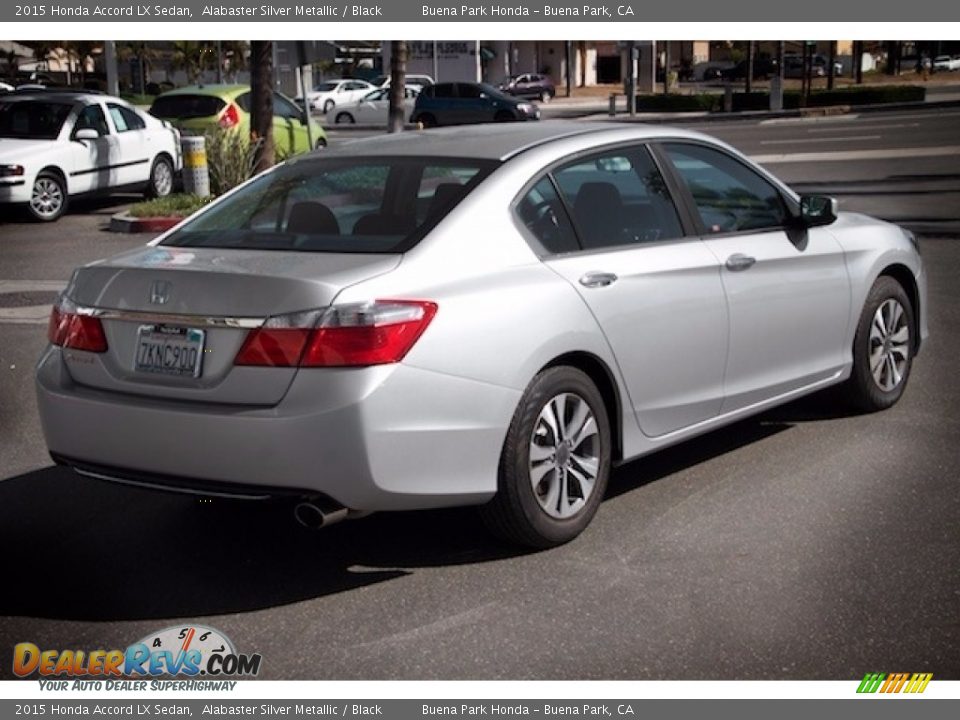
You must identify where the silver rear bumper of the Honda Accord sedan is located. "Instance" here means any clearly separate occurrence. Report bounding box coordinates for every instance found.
[37,347,520,511]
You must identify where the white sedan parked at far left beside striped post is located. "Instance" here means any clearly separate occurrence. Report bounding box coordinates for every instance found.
[0,91,181,221]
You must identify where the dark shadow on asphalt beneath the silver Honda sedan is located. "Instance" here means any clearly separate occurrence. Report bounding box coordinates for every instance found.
[0,390,856,621]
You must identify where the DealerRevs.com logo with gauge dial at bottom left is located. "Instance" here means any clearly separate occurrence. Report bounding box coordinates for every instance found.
[13,625,262,689]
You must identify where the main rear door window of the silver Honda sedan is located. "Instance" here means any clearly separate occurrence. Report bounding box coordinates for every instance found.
[553,148,684,250]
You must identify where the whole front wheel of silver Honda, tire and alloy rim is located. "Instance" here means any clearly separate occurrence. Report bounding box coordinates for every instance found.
[847,276,915,412]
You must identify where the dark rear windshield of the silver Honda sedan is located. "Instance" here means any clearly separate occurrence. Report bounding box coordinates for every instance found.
[162,157,496,253]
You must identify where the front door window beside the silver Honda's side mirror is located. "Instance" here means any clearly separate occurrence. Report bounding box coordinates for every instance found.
[663,143,788,234]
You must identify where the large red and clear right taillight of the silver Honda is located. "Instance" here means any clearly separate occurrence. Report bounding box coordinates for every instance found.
[234,300,437,367]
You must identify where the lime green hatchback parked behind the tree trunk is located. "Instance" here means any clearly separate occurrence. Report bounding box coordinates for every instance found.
[150,85,327,155]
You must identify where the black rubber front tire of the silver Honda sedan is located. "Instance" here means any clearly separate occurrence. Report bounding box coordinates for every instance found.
[846,275,917,412]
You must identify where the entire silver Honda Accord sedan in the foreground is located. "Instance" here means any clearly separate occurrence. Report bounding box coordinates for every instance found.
[37,123,927,547]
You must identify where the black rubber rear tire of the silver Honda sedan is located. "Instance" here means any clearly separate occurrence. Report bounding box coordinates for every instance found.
[480,366,612,549]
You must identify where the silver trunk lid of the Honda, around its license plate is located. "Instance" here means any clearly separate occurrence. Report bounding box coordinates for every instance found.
[64,246,401,405]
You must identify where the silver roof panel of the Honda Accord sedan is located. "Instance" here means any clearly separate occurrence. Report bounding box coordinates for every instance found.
[309,120,702,161]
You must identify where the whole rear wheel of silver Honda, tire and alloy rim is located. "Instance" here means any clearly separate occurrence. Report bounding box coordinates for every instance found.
[481,367,611,548]
